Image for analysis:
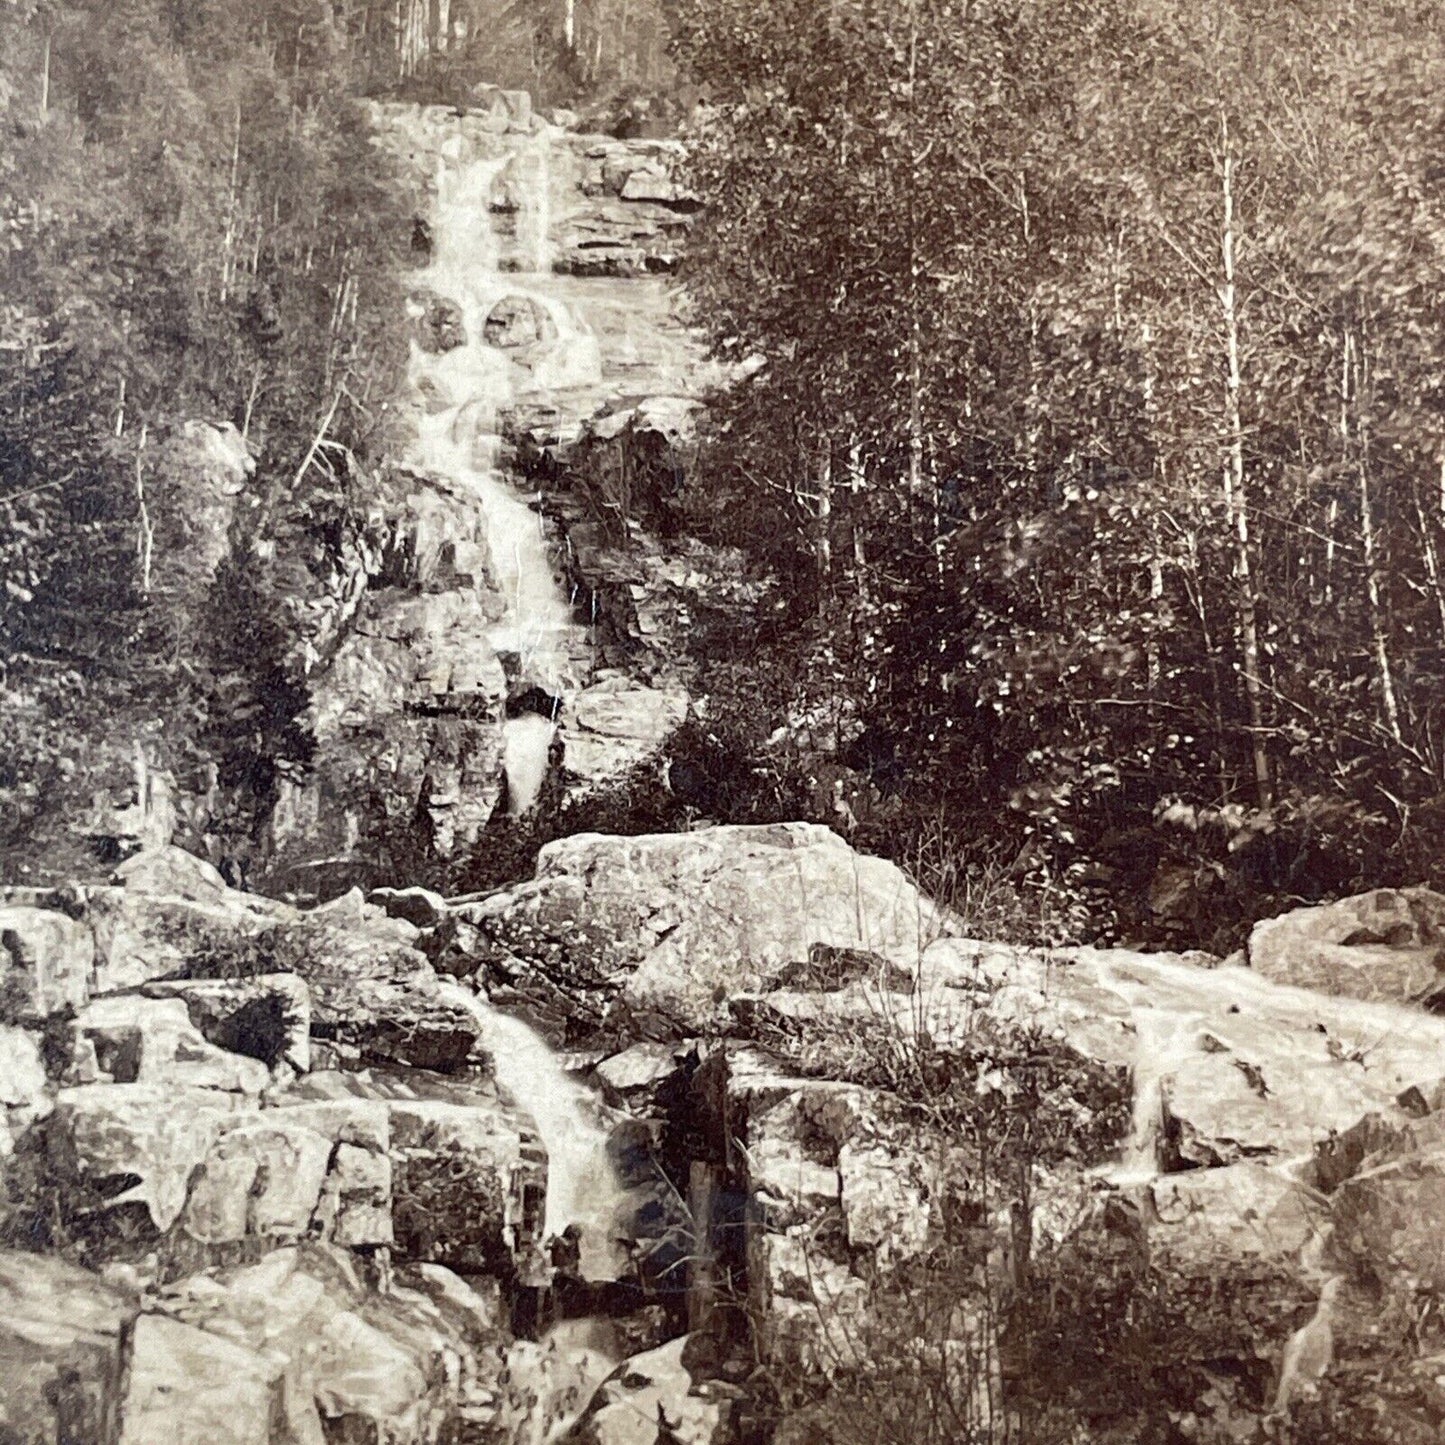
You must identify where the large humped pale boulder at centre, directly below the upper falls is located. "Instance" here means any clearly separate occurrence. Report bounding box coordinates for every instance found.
[461,824,945,1035]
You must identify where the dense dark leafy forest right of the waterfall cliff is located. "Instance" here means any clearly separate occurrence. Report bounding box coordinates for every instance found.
[678,0,1445,946]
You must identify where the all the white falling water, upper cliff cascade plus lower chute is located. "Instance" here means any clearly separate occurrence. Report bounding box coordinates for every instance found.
[412,129,624,1416]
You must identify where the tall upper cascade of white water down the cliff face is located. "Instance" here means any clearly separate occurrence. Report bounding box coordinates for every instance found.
[412,131,601,814]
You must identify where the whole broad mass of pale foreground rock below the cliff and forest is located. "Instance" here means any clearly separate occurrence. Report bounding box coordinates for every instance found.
[14,825,1445,1445]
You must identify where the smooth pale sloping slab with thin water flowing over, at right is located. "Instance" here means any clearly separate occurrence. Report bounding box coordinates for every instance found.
[919,939,1445,1173]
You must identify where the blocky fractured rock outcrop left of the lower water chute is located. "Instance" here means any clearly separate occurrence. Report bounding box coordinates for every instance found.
[3,851,546,1270]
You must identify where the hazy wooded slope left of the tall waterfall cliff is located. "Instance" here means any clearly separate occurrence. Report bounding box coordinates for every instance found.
[0,0,405,866]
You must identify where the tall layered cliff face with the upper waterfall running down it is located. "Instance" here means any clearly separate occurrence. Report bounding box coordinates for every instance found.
[258,105,712,896]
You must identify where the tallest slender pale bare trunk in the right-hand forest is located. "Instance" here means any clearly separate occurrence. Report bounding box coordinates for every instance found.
[1220,110,1273,808]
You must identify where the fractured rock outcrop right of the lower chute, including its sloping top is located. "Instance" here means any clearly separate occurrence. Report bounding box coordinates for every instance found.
[679,913,1445,1421]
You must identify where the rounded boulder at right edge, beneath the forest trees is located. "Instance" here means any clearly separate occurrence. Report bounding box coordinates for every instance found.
[1248,887,1445,1001]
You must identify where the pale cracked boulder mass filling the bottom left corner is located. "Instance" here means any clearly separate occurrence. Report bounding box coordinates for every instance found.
[0,1244,504,1445]
